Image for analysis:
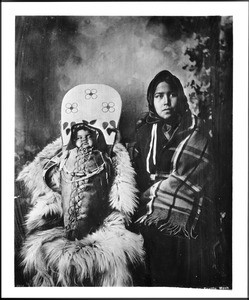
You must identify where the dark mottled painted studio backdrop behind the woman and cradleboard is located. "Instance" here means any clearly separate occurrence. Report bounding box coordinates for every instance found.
[15,16,233,286]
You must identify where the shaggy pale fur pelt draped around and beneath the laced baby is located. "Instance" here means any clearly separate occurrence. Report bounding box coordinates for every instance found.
[17,139,144,286]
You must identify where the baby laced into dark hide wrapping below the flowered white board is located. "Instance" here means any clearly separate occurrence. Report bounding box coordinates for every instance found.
[45,122,112,240]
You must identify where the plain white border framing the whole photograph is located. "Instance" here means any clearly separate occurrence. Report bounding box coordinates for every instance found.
[1,1,248,298]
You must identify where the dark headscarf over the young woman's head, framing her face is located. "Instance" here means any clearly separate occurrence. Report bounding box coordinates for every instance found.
[147,70,189,115]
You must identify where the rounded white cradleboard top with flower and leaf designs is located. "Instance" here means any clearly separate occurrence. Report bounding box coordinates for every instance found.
[61,84,122,149]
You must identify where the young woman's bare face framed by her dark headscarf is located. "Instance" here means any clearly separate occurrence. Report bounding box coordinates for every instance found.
[154,82,178,120]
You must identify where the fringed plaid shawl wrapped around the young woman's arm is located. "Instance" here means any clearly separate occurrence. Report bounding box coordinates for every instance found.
[137,128,212,238]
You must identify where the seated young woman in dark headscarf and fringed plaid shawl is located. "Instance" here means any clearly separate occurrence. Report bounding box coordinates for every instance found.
[133,70,219,287]
